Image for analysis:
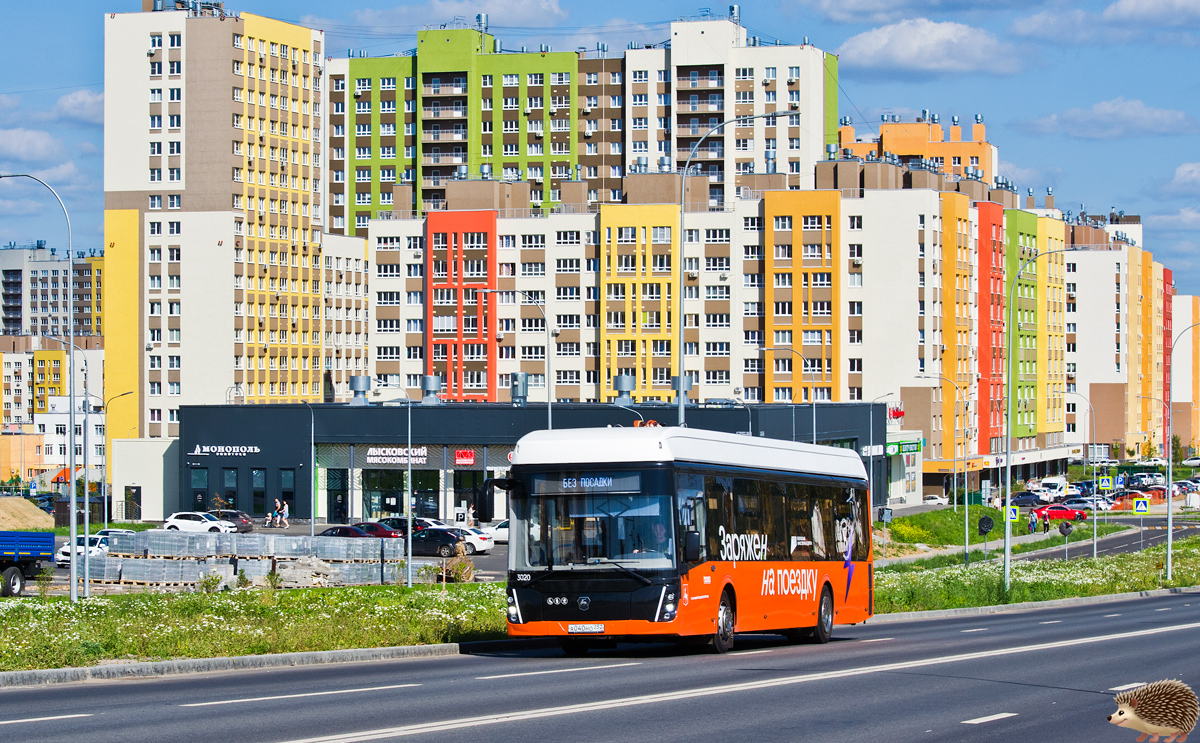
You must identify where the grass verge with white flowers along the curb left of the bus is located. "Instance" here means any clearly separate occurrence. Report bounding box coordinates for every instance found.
[0,583,506,671]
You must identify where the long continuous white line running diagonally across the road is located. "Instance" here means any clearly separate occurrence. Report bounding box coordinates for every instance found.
[270,622,1200,743]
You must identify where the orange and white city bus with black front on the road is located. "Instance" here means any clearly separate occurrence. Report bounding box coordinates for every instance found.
[493,427,874,653]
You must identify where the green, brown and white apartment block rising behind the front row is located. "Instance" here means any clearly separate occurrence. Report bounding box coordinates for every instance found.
[329,16,838,236]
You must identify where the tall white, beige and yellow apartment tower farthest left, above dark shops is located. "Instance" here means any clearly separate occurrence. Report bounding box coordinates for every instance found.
[104,0,367,456]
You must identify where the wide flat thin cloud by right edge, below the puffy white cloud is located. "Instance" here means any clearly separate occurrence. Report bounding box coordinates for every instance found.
[1021,97,1196,139]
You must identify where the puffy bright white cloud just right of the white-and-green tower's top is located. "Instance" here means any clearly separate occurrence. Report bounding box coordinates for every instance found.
[838,18,1020,77]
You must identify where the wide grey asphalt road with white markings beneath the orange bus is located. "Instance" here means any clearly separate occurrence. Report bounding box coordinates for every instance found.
[7,594,1200,743]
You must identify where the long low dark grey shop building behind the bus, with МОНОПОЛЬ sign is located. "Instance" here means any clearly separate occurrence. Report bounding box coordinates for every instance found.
[174,402,890,523]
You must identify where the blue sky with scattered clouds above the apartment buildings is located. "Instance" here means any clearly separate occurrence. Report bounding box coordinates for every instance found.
[0,0,1200,294]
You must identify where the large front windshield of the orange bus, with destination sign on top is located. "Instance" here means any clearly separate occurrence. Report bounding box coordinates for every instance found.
[509,471,676,570]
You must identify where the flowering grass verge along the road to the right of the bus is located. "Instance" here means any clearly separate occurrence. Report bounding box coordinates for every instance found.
[875,537,1200,613]
